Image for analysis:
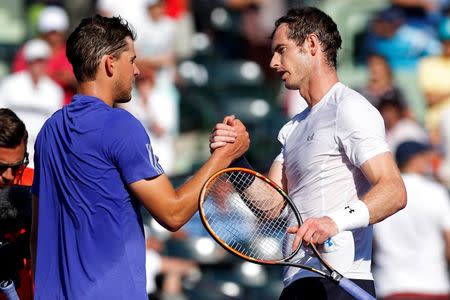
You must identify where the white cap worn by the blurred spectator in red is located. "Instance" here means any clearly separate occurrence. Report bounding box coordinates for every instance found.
[38,6,69,33]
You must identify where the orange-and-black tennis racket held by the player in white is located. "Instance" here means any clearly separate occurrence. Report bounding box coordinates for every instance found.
[199,168,375,300]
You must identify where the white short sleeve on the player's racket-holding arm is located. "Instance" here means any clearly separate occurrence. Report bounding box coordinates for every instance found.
[336,97,390,167]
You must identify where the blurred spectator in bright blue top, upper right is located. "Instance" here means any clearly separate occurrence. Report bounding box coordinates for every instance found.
[363,8,440,71]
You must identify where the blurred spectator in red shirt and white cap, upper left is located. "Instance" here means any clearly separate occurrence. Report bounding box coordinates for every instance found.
[12,6,76,104]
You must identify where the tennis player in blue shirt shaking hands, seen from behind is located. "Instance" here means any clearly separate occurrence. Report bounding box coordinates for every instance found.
[31,16,249,300]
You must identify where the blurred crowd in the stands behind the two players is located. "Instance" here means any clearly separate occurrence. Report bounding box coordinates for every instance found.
[0,0,450,299]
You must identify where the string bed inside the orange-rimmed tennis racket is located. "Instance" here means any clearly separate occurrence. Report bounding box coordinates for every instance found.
[203,171,298,261]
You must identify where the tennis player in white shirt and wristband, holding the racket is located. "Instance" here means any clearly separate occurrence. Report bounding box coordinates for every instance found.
[210,7,406,299]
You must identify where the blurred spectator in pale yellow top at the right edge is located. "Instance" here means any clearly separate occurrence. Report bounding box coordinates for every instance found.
[418,9,450,145]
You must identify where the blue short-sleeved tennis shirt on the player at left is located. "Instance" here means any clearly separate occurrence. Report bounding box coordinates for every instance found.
[32,95,163,300]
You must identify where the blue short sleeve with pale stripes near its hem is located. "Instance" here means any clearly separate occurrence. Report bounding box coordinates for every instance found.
[103,109,164,184]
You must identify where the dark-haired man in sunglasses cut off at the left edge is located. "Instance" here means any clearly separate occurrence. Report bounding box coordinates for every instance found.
[0,108,33,300]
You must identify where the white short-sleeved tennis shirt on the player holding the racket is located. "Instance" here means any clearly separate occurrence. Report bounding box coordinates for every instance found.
[275,83,389,286]
